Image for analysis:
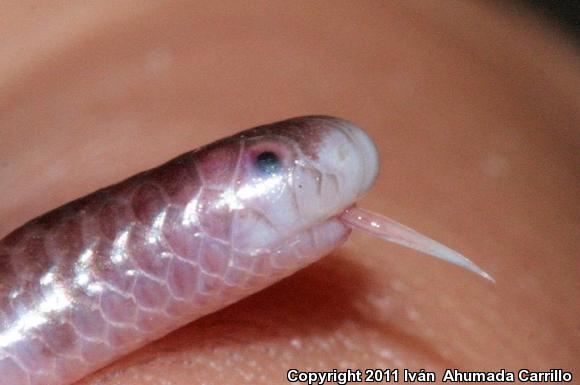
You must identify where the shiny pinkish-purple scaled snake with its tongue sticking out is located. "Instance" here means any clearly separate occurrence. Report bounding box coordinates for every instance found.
[0,116,492,385]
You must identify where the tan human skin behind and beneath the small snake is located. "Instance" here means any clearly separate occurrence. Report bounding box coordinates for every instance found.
[0,1,580,385]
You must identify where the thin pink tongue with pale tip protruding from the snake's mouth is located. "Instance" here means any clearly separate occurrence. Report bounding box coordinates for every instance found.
[340,207,495,282]
